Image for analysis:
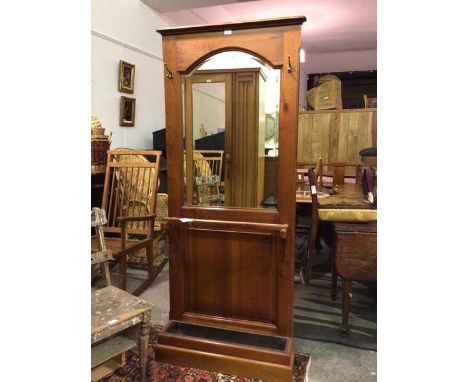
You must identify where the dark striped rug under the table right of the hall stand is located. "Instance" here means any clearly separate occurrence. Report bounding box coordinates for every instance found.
[294,273,377,351]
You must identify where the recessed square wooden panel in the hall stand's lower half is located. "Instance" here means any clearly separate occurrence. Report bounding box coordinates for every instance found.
[186,229,277,323]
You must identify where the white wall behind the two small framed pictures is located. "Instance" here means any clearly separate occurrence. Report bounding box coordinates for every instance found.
[91,0,169,149]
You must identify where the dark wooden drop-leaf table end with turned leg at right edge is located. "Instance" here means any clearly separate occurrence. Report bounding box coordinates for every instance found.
[332,221,377,335]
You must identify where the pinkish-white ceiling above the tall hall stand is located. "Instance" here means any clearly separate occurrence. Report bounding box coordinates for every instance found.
[142,0,377,53]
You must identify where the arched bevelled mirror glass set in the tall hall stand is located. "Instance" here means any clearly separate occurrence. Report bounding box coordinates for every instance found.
[181,51,281,208]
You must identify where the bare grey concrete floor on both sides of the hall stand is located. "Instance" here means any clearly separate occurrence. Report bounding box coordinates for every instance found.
[118,265,377,382]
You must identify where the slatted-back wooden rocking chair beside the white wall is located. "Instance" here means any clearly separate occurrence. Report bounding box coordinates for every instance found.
[91,150,167,296]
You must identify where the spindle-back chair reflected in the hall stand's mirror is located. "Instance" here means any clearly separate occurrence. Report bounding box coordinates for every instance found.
[193,150,224,206]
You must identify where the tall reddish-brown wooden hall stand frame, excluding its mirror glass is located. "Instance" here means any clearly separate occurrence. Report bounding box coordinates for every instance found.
[156,17,305,382]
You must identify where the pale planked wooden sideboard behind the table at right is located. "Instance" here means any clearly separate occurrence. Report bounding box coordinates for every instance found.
[297,109,377,175]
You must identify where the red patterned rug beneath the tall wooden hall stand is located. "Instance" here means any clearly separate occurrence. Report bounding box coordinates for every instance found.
[102,326,310,382]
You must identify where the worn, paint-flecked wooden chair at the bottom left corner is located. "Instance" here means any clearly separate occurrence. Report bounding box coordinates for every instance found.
[91,208,153,381]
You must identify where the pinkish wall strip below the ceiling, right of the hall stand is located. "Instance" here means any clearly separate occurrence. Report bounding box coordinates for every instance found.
[301,50,377,74]
